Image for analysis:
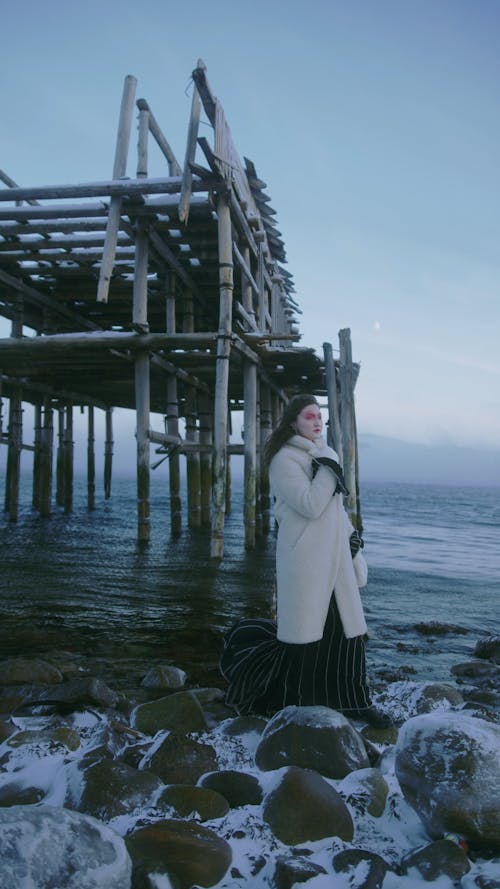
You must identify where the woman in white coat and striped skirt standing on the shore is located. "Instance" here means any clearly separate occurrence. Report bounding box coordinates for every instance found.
[221,395,390,727]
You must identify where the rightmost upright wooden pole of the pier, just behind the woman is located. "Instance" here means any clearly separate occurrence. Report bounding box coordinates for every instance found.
[339,328,357,525]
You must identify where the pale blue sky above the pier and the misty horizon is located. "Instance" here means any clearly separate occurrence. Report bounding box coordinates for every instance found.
[0,0,500,458]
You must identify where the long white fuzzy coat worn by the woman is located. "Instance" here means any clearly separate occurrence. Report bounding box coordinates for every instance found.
[269,435,367,643]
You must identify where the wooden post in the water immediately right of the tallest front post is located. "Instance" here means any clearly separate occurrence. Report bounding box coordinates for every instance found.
[243,361,257,549]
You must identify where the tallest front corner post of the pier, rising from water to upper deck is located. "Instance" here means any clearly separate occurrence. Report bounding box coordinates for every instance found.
[210,192,233,559]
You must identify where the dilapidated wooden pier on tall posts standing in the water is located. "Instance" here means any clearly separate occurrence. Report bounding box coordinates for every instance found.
[0,60,361,559]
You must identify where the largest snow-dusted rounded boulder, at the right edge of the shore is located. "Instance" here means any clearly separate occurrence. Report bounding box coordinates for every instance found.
[395,711,500,850]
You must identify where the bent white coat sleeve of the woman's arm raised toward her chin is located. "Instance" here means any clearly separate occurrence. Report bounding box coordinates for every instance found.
[269,449,337,519]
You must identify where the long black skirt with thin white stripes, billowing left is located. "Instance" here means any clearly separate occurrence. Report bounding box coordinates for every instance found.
[220,595,371,716]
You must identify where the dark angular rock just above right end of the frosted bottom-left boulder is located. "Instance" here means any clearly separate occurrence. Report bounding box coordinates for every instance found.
[77,759,163,821]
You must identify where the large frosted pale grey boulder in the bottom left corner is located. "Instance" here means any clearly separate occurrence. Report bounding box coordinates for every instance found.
[0,806,132,889]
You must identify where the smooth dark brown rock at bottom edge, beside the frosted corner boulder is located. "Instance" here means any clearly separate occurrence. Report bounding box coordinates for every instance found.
[126,819,232,889]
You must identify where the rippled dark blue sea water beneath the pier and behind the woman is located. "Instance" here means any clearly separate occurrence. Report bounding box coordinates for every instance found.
[0,478,500,682]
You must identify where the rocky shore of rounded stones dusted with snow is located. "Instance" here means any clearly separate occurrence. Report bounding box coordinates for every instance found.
[0,637,500,889]
